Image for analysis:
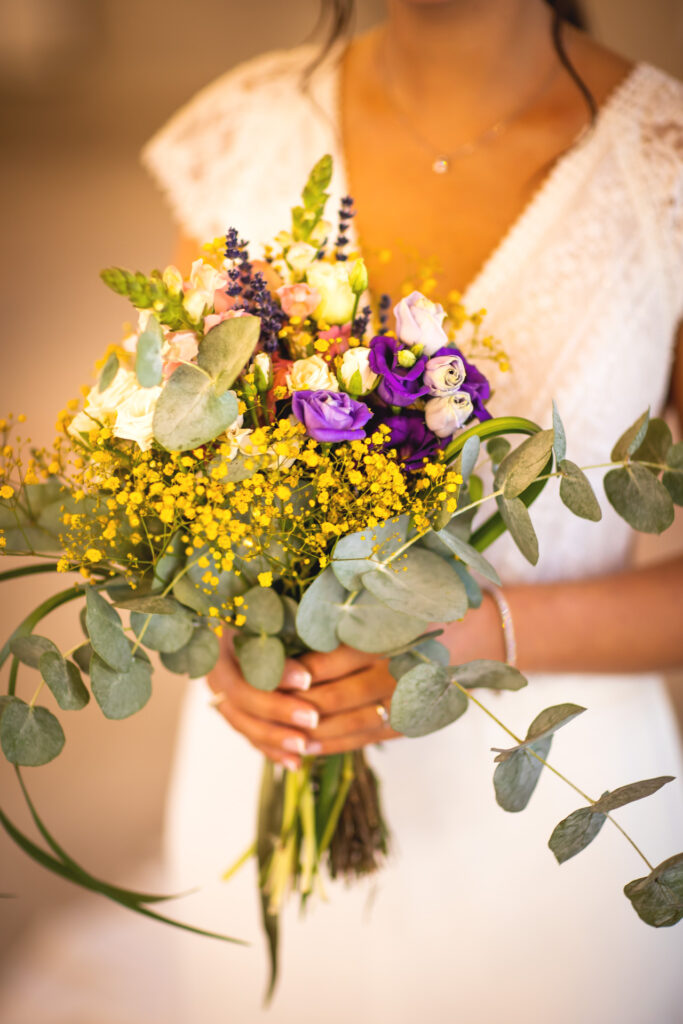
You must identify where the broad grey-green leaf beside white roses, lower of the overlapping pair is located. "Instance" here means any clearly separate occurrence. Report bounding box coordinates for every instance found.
[154,364,239,452]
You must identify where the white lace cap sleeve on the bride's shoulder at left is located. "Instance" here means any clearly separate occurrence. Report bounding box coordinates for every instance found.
[141,47,330,249]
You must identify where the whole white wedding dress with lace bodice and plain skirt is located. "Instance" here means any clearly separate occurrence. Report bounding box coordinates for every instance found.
[143,49,683,1024]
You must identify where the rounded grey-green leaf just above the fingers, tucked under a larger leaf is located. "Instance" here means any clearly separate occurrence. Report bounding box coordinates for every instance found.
[335,591,425,654]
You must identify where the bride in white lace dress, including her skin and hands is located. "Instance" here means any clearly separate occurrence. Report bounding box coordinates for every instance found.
[144,0,683,1024]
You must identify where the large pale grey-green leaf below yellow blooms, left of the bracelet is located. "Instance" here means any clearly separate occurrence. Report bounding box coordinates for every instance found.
[362,548,468,623]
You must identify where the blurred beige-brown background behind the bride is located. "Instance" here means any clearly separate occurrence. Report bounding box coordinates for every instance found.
[0,0,683,983]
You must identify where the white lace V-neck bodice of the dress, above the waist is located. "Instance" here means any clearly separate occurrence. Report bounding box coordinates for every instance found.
[142,47,683,582]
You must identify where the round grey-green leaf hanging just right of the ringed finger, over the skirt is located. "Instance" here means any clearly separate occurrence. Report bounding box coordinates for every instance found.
[389,665,469,736]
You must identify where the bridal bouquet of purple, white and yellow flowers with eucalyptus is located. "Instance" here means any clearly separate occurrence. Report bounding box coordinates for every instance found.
[0,158,683,995]
